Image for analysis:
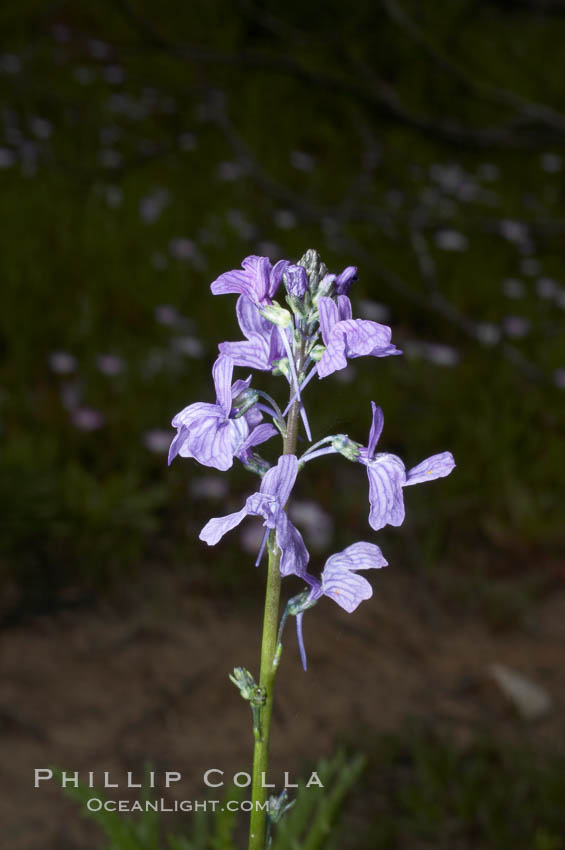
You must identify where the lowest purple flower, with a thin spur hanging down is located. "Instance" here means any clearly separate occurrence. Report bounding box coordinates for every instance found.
[296,542,388,670]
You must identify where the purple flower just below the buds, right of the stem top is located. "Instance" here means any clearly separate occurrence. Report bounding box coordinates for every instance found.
[318,295,402,378]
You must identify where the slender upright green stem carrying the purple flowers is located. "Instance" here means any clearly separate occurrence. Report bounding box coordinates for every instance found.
[249,390,300,850]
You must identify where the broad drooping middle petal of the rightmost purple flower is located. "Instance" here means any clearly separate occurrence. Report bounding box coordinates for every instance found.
[367,454,406,531]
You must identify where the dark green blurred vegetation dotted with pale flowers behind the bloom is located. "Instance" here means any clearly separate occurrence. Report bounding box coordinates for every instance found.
[0,0,565,613]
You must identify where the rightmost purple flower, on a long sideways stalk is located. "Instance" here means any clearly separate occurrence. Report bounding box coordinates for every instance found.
[358,401,455,531]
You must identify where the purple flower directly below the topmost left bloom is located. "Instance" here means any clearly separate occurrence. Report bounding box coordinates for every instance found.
[218,295,286,371]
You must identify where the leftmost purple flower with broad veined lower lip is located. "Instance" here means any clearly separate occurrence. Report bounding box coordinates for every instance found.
[169,356,276,470]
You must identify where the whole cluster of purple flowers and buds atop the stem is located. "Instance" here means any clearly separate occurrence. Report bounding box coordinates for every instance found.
[169,251,455,669]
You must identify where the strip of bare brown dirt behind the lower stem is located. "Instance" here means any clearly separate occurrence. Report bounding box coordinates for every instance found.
[0,570,565,850]
